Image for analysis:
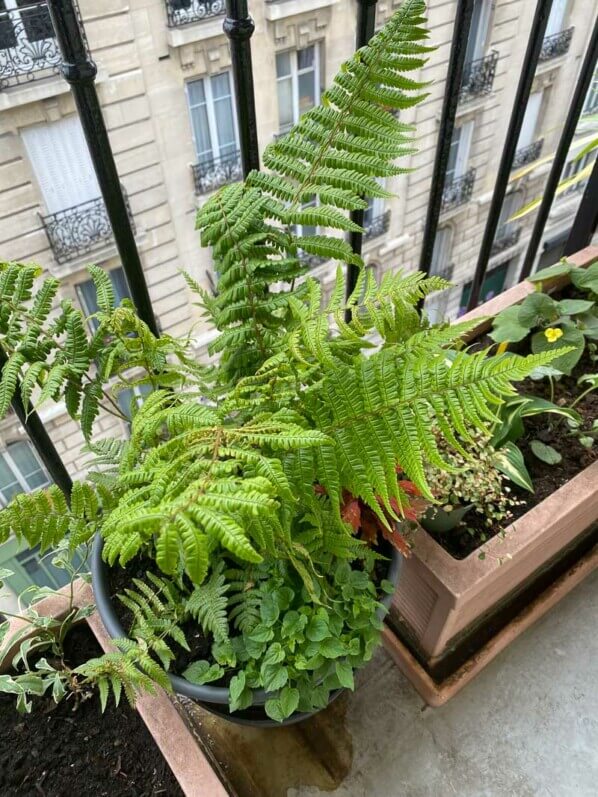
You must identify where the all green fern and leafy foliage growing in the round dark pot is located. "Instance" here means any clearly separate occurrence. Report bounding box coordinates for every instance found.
[0,0,568,720]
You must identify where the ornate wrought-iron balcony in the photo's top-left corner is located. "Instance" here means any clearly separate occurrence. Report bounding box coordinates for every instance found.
[0,2,64,90]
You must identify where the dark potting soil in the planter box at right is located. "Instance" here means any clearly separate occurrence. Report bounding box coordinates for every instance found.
[432,326,598,559]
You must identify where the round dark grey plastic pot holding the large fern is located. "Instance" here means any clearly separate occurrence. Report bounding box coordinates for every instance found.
[91,535,402,728]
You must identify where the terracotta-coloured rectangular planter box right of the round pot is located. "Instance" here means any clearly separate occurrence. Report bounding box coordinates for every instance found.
[386,247,598,688]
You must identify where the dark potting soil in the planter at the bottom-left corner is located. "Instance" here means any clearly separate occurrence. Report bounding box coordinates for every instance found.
[0,625,183,797]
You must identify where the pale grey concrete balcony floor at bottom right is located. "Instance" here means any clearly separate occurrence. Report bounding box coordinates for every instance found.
[288,572,598,797]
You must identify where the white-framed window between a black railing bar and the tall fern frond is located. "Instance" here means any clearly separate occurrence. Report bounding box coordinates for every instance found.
[276,44,320,133]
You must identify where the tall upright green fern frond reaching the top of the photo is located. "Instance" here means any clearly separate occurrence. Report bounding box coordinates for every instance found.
[197,0,428,381]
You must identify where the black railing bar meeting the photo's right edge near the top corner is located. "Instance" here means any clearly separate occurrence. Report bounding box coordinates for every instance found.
[519,18,598,279]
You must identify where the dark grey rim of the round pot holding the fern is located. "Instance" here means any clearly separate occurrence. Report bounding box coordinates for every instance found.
[90,534,403,706]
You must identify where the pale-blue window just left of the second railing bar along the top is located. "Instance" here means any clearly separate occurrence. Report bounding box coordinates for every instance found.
[186,72,239,165]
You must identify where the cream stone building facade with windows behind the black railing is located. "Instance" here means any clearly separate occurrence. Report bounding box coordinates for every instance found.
[0,0,598,604]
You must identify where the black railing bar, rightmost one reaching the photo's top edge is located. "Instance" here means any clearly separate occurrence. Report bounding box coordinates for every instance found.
[467,0,552,310]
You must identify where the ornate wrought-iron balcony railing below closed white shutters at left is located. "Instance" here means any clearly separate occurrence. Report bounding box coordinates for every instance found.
[42,197,132,264]
